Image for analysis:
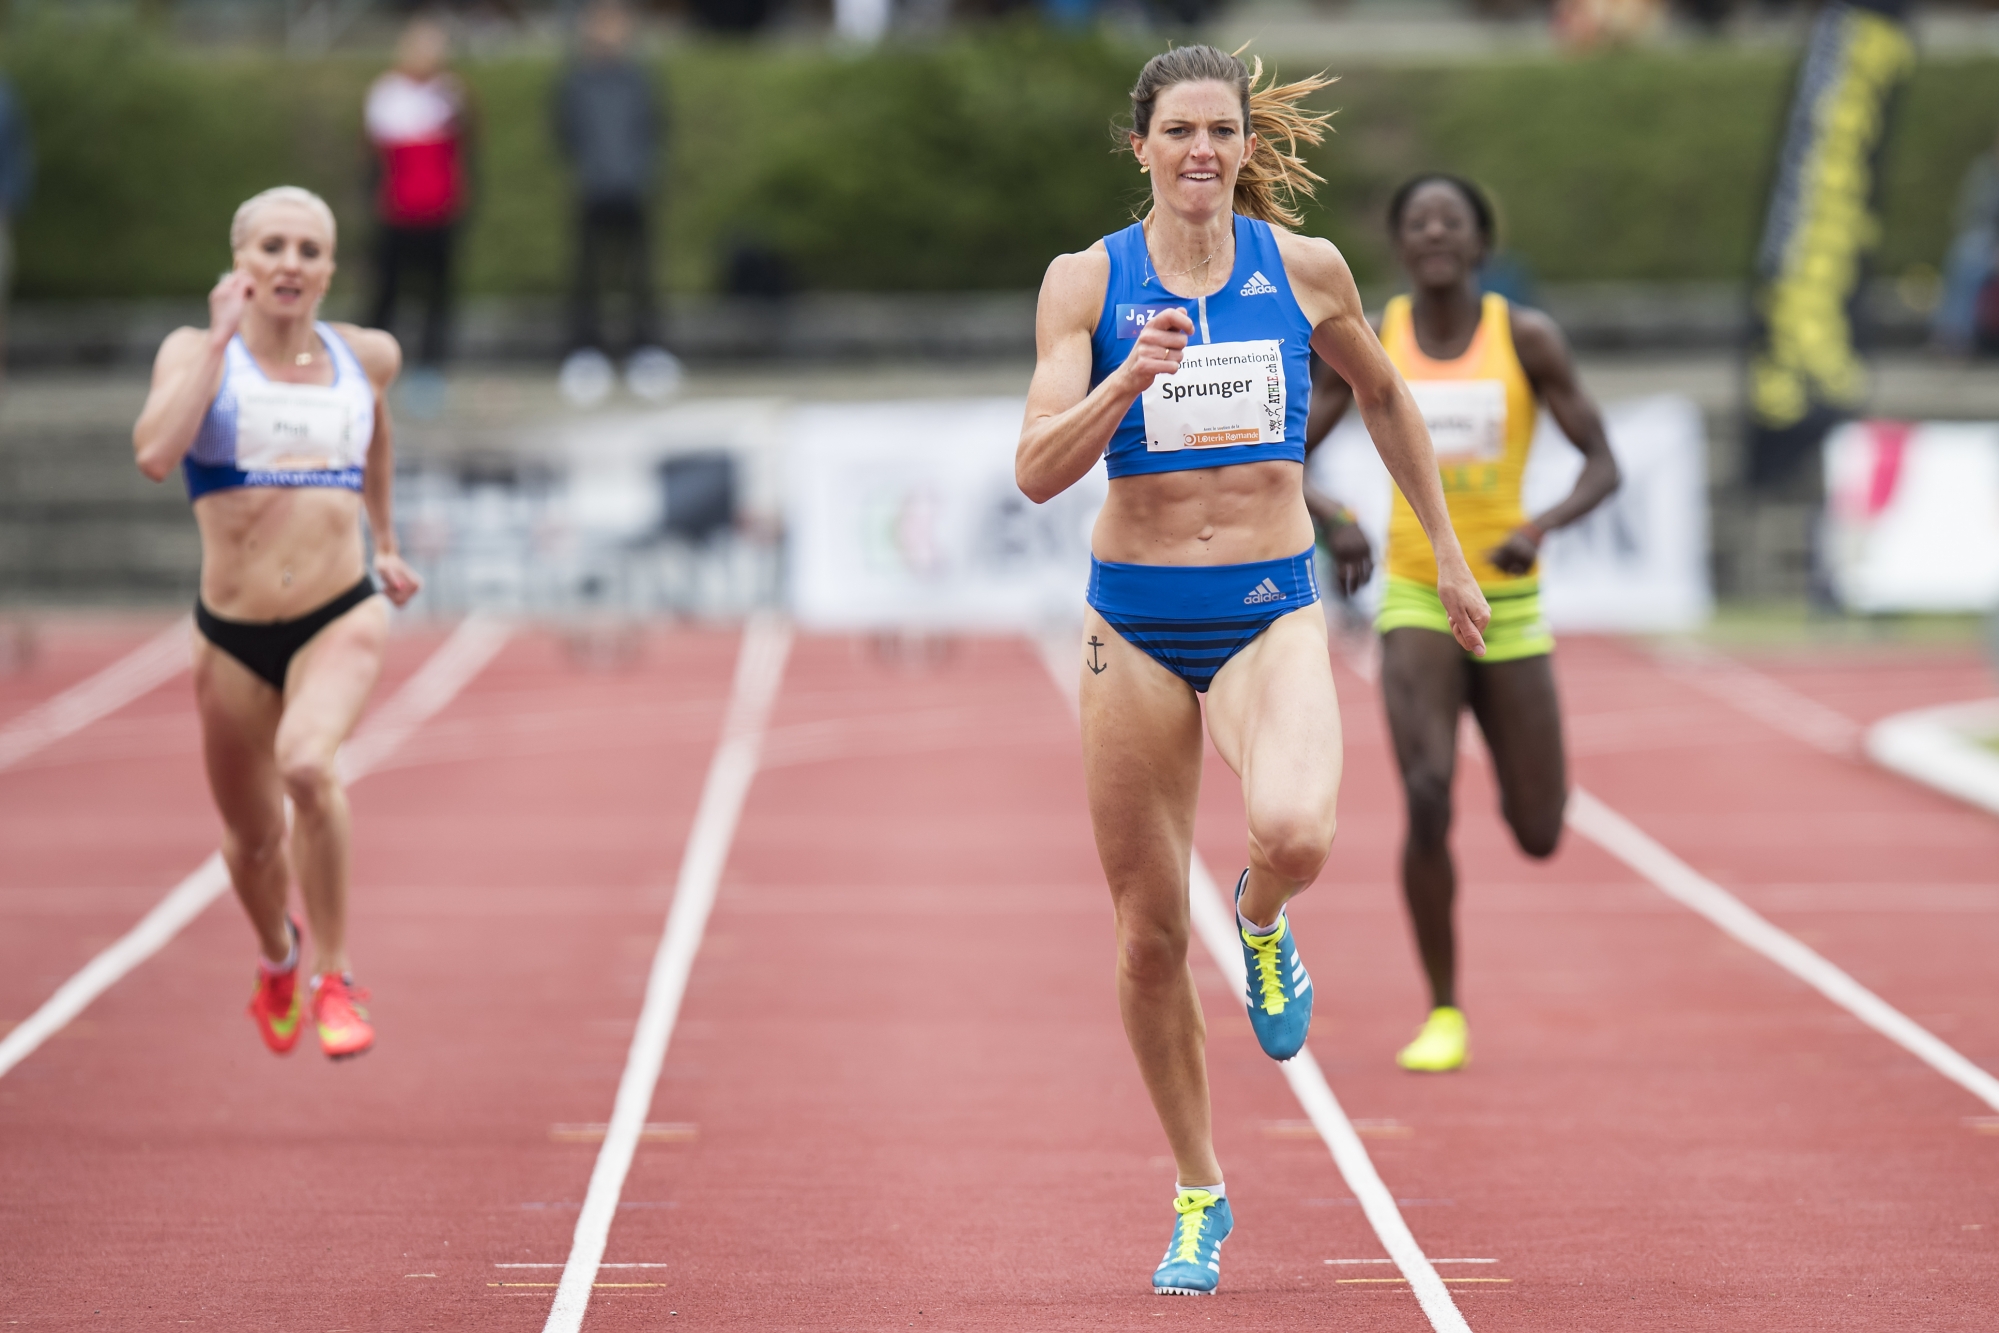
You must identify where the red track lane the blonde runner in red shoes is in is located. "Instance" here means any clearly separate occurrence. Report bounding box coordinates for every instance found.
[0,634,734,1329]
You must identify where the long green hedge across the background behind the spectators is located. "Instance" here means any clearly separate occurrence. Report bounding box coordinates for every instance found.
[0,24,1999,300]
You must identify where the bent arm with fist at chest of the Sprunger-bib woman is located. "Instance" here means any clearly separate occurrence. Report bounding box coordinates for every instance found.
[1013,246,1193,504]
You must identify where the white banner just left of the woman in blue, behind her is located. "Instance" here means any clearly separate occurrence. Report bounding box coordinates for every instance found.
[786,398,1107,630]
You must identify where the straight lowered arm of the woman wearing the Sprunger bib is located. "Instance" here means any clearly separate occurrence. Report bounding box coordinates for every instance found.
[1271,228,1491,656]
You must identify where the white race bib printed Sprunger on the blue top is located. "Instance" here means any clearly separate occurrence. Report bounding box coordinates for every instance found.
[1139,338,1285,454]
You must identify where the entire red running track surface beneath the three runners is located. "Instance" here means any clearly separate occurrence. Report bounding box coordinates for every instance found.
[0,634,1999,1333]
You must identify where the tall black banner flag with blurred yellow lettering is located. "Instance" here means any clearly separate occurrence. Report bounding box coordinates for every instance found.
[1747,0,1915,488]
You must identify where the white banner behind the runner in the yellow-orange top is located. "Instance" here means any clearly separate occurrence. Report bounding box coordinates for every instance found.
[1311,394,1713,634]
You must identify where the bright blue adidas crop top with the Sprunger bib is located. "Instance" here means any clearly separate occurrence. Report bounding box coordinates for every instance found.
[1089,216,1311,478]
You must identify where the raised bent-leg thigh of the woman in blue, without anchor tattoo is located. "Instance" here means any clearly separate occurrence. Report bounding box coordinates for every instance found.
[1207,604,1343,879]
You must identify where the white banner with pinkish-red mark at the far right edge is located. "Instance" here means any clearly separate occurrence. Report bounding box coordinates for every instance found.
[1821,422,1999,612]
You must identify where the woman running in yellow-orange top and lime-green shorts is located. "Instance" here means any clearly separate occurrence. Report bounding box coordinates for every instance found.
[1309,174,1617,1073]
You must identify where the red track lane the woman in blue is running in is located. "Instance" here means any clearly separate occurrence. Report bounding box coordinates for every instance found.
[586,640,1429,1333]
